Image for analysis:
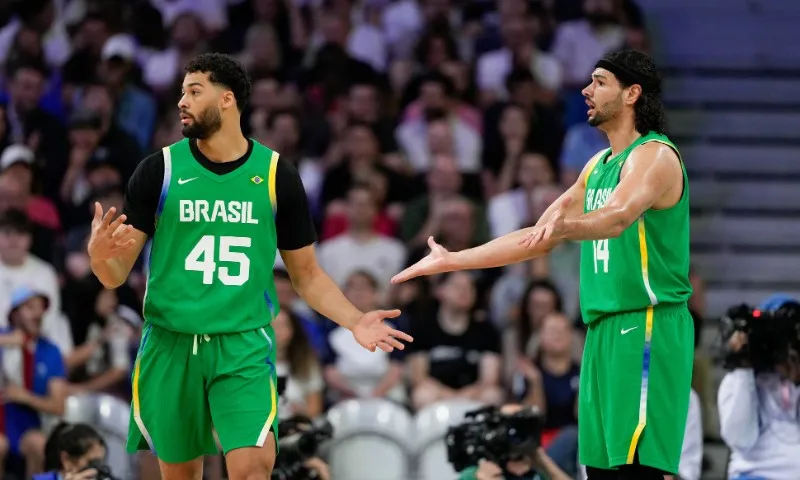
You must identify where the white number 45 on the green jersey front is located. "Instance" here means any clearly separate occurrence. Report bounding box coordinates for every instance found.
[183,235,252,286]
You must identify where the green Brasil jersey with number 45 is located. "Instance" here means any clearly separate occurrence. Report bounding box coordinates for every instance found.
[144,140,279,334]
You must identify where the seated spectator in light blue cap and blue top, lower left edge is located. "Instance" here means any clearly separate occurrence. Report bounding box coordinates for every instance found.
[0,287,67,478]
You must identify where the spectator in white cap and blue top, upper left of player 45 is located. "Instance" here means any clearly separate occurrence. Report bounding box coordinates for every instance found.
[98,34,157,150]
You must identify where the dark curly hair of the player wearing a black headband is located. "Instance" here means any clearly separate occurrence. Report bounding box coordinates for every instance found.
[605,50,667,135]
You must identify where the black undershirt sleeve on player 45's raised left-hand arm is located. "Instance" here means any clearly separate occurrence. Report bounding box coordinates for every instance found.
[122,150,164,237]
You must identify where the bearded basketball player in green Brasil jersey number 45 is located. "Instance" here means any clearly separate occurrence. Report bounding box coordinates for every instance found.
[89,54,411,480]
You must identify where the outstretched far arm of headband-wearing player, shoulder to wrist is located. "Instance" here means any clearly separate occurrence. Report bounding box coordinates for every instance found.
[448,152,602,270]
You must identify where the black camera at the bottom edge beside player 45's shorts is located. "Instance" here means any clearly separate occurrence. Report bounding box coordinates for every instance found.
[272,416,333,480]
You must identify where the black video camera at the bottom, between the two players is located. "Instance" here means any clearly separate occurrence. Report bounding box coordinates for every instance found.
[445,407,544,471]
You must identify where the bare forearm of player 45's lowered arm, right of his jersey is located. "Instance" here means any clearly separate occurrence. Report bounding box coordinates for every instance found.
[292,267,364,330]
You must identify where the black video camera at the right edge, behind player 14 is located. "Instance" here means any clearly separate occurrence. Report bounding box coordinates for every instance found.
[720,302,800,372]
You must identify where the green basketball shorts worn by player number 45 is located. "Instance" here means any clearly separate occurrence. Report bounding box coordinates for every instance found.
[128,323,278,463]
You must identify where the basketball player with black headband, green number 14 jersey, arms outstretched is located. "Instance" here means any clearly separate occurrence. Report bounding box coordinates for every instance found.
[393,51,694,480]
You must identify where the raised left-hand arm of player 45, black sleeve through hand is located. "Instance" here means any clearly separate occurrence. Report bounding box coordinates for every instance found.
[89,151,164,288]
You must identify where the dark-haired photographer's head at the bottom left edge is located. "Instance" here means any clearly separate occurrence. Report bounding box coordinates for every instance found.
[33,423,114,480]
